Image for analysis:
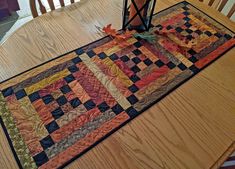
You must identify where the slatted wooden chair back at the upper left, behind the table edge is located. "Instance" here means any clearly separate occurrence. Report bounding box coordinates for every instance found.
[29,0,74,18]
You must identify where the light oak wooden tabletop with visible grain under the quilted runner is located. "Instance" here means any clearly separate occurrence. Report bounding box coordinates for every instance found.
[0,0,235,169]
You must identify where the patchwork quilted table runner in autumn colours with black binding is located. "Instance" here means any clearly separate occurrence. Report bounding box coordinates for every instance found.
[0,2,235,169]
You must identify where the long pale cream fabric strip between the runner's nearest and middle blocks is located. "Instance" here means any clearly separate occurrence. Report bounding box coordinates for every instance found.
[80,54,131,109]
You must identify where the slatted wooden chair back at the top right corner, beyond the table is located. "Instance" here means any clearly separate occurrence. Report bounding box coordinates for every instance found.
[199,0,235,18]
